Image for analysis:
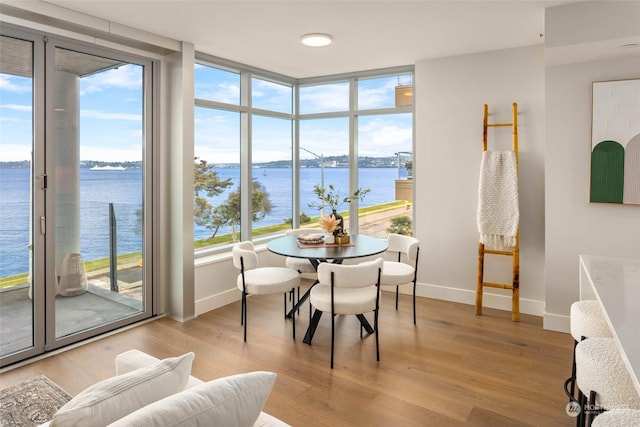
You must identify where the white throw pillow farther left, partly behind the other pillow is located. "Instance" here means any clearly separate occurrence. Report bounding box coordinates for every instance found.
[51,353,194,427]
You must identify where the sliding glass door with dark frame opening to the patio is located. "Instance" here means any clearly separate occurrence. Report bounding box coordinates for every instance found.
[0,27,155,365]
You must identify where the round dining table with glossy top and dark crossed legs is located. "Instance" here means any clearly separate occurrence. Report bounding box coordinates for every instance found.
[267,234,388,344]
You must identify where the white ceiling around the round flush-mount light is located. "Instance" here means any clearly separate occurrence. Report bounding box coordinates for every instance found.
[37,0,576,78]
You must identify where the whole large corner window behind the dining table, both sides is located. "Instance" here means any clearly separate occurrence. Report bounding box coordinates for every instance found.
[194,59,413,252]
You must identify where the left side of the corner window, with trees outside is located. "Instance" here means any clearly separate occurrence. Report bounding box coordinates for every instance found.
[194,61,294,252]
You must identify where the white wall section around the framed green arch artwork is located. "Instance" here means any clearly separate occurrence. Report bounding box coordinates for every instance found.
[544,56,640,330]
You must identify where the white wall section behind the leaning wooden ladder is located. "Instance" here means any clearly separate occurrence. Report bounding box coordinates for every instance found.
[414,46,545,315]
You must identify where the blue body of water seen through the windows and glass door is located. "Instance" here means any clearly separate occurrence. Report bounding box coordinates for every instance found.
[0,168,404,277]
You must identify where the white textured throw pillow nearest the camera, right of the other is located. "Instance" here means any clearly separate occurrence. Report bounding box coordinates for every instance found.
[110,371,276,427]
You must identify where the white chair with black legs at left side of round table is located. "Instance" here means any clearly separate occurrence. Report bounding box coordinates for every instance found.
[232,241,300,342]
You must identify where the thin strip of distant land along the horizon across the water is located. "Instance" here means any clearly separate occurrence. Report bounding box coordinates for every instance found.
[0,155,404,169]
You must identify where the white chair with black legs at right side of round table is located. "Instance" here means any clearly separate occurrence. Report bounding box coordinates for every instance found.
[380,233,420,325]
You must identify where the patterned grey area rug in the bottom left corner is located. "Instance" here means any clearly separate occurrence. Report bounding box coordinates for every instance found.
[0,375,71,427]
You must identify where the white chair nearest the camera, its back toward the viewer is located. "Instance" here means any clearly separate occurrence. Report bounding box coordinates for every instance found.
[310,258,383,369]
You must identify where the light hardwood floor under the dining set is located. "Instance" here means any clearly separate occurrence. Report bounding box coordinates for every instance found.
[0,284,575,426]
